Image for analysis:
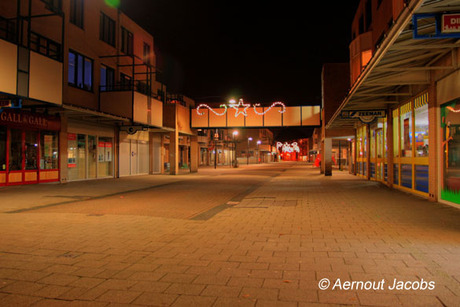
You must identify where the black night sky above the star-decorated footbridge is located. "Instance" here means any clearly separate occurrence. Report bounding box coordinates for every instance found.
[121,0,359,105]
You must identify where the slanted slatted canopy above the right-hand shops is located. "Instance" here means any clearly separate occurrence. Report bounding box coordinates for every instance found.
[326,0,460,129]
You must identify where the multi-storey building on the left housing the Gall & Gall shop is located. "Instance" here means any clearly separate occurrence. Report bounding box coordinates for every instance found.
[0,0,197,185]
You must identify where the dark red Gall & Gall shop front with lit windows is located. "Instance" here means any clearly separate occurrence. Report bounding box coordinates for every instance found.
[0,109,61,185]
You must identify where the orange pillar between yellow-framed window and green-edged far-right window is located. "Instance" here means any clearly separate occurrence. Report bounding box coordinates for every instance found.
[428,81,440,201]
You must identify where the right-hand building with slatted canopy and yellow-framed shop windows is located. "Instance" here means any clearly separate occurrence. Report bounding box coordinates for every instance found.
[323,0,460,206]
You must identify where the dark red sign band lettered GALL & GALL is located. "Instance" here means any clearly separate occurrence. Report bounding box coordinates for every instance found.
[0,109,61,131]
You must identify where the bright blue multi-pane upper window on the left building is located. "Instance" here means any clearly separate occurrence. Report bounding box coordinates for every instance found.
[68,51,93,91]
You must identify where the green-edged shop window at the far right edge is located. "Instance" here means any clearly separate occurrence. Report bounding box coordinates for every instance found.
[441,100,460,204]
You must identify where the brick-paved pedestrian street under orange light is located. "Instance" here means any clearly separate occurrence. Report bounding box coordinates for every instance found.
[0,163,460,306]
